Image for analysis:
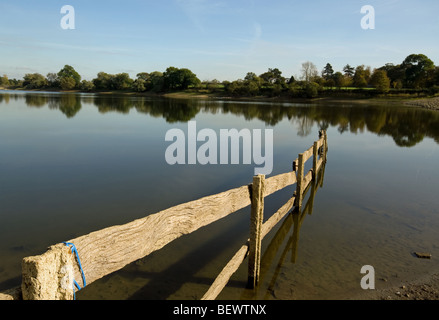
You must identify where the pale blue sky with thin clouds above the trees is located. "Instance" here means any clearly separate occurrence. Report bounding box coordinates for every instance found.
[0,0,439,81]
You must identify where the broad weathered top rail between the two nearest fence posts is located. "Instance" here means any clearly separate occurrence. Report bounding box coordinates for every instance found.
[65,186,251,284]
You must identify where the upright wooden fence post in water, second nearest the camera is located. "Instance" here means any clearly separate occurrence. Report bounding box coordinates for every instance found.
[248,175,265,289]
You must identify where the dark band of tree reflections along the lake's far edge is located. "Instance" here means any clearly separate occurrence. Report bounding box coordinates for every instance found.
[0,93,439,147]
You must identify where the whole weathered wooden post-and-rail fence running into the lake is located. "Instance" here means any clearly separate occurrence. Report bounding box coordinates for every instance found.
[0,131,327,300]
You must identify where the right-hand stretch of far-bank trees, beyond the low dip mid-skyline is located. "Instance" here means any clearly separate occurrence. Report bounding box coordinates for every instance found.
[223,54,439,98]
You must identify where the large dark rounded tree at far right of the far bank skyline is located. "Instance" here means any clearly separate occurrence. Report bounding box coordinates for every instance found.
[401,54,434,88]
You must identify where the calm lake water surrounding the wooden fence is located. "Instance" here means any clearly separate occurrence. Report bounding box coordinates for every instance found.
[0,92,439,300]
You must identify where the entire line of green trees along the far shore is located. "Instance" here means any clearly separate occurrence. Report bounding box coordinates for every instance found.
[0,54,439,98]
